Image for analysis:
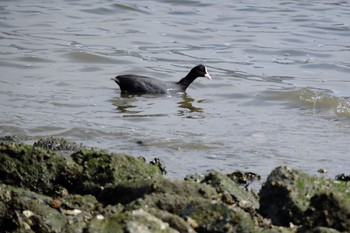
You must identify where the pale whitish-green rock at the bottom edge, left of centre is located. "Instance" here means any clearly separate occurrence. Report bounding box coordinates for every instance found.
[86,209,178,233]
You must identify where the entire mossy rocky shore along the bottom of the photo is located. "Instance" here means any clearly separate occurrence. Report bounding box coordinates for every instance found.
[0,139,350,233]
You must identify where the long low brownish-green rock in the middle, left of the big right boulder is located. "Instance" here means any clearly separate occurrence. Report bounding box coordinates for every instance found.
[98,178,218,209]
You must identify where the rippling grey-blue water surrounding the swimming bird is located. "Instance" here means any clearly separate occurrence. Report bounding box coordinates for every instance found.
[0,0,350,182]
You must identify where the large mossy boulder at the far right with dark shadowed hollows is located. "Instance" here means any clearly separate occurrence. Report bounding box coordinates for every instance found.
[260,167,350,231]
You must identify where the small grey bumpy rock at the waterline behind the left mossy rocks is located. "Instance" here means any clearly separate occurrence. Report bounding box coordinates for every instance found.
[33,137,83,151]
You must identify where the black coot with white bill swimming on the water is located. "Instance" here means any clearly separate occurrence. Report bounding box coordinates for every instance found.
[112,65,211,94]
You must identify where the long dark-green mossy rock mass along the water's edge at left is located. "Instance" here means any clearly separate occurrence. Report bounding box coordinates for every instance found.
[0,142,161,196]
